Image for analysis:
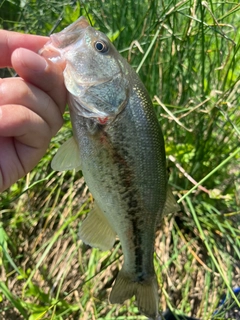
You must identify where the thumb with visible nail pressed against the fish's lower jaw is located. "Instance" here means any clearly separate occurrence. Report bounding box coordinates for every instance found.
[12,49,67,113]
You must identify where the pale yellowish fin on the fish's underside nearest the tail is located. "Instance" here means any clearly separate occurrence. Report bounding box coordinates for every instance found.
[79,203,116,251]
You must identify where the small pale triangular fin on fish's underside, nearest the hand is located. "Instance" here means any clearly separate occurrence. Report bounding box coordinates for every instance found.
[51,137,81,171]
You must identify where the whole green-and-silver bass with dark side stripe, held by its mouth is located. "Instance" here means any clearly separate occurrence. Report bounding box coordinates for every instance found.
[40,17,177,319]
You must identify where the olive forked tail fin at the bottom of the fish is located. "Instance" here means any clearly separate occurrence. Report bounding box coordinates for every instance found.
[109,270,159,319]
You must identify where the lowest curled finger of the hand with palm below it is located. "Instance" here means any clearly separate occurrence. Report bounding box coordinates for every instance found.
[0,105,51,192]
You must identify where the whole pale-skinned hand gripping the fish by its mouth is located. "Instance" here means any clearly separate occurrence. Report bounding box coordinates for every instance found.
[0,30,66,192]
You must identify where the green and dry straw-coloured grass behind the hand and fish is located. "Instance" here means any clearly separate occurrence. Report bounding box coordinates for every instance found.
[0,0,240,320]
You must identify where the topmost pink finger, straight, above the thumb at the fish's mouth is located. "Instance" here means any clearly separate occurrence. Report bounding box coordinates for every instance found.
[0,30,49,68]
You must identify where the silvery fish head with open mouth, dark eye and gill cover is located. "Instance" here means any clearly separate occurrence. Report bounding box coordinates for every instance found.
[41,17,129,124]
